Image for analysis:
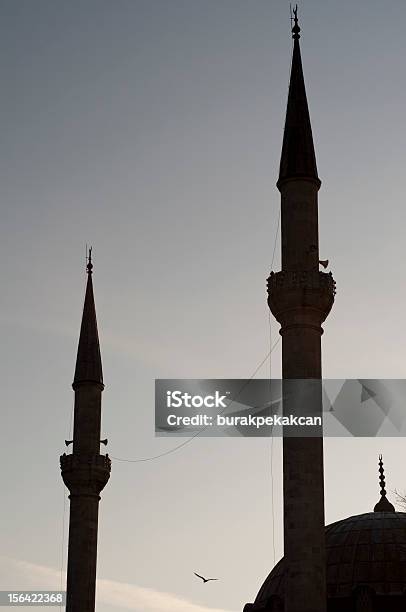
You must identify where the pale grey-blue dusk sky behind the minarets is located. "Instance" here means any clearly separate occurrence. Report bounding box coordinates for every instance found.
[0,0,406,612]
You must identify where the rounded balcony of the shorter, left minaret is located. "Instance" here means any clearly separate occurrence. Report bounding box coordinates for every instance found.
[60,453,111,496]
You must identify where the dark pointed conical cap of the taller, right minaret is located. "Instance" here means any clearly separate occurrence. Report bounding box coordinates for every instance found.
[277,6,320,187]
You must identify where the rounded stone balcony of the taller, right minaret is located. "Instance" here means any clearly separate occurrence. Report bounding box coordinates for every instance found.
[267,270,336,327]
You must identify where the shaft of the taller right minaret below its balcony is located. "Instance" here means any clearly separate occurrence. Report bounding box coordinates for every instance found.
[282,317,327,612]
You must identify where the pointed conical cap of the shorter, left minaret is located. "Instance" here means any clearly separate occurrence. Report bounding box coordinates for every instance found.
[73,249,103,388]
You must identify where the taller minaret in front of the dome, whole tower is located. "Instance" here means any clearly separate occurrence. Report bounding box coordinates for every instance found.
[268,7,335,612]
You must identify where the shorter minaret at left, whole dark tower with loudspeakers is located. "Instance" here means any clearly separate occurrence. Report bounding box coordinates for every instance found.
[61,249,111,612]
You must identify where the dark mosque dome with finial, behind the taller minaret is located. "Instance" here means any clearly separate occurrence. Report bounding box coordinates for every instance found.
[244,456,406,612]
